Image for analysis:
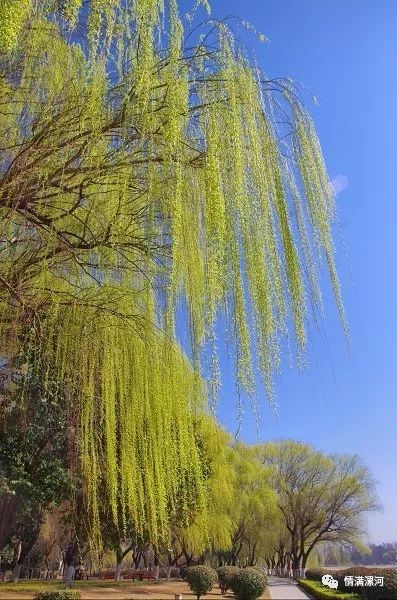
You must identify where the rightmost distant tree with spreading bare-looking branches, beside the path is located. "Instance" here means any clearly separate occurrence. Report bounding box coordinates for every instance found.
[258,441,377,572]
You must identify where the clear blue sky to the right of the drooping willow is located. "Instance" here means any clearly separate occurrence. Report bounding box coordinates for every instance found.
[183,0,397,543]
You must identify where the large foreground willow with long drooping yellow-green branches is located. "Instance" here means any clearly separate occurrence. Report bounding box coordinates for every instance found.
[0,0,345,538]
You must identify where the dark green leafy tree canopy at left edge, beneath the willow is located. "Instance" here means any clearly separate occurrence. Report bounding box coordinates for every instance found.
[0,354,74,551]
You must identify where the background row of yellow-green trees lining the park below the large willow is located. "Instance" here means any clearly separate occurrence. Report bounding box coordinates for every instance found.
[0,408,376,580]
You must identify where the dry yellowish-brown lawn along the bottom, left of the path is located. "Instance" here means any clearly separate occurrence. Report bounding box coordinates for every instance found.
[0,580,270,600]
